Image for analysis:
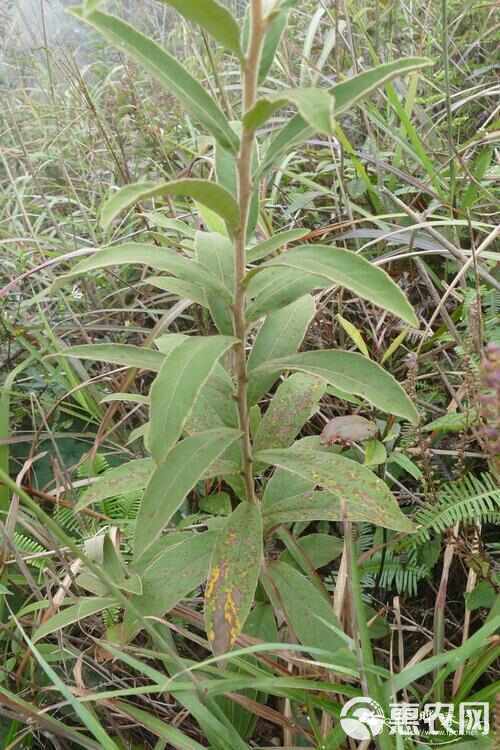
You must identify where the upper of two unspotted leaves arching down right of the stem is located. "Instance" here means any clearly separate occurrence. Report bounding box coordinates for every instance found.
[258,245,419,328]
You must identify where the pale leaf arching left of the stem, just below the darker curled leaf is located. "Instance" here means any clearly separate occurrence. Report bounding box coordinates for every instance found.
[62,242,232,303]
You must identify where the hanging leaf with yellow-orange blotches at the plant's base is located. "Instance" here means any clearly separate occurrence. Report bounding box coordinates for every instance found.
[205,501,263,654]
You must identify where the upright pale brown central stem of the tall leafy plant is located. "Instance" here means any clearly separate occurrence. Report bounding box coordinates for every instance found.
[233,0,266,502]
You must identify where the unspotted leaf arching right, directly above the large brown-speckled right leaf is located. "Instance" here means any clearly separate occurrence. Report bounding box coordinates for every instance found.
[250,349,418,424]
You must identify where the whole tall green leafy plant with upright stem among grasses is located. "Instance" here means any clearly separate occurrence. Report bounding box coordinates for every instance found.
[38,0,436,740]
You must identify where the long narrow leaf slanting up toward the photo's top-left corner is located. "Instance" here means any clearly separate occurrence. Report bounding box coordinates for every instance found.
[70,8,239,152]
